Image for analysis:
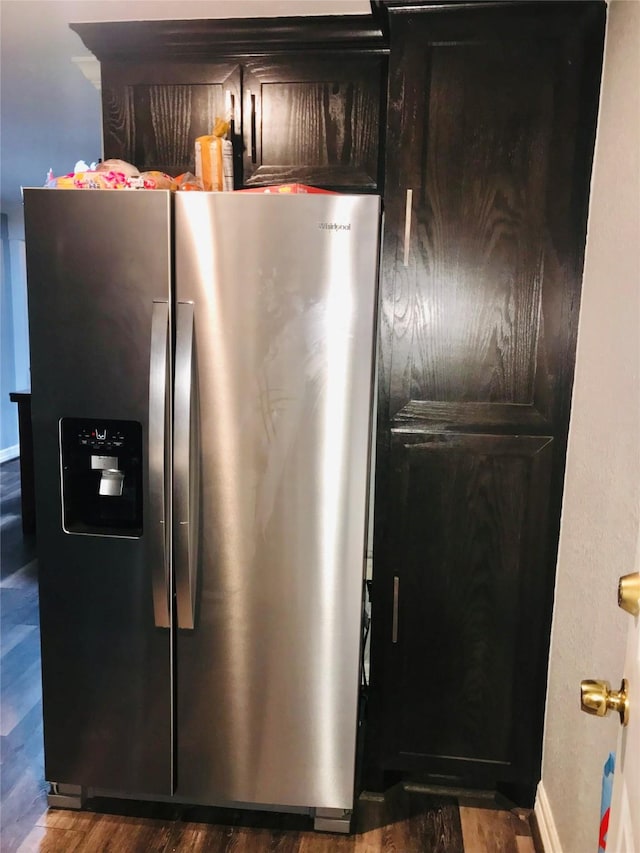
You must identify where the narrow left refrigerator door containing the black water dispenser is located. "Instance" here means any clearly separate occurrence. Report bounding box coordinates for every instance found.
[24,189,173,794]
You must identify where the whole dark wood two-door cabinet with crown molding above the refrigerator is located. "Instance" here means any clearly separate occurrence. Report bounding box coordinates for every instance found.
[72,16,387,192]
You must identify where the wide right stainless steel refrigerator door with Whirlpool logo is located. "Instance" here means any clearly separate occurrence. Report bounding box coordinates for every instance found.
[173,193,380,809]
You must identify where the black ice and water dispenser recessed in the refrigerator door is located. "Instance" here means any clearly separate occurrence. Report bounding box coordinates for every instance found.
[60,418,143,536]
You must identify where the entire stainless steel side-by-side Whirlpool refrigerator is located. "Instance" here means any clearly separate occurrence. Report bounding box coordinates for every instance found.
[24,189,380,829]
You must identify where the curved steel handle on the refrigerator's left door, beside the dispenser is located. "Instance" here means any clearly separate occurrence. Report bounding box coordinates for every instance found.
[149,302,171,628]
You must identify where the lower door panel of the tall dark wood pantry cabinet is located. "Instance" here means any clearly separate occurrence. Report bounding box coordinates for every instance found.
[387,433,553,772]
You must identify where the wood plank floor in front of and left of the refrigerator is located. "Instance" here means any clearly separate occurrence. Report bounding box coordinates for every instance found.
[0,461,535,853]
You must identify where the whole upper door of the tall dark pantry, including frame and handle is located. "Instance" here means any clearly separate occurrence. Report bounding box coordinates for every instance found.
[384,3,601,430]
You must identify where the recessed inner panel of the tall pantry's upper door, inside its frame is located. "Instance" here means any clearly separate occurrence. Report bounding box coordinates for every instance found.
[390,39,553,411]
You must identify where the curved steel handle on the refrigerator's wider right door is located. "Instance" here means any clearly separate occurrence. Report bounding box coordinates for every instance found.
[173,302,200,629]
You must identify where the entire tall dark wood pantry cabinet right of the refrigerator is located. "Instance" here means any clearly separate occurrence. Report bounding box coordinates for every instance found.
[368,2,604,803]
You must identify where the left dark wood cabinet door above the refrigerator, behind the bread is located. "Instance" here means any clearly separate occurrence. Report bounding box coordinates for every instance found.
[102,61,242,176]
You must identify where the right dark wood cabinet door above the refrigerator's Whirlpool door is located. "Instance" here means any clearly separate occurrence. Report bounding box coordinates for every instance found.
[243,54,386,192]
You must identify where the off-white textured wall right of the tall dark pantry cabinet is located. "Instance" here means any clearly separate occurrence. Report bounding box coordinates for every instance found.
[537,0,640,853]
